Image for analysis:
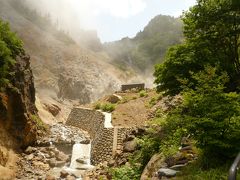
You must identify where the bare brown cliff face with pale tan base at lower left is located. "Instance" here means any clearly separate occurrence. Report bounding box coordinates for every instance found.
[0,55,46,179]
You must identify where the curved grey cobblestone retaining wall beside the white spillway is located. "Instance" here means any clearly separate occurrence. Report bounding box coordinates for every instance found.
[66,108,131,165]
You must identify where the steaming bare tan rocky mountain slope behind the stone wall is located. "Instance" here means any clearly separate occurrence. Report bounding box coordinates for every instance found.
[0,0,133,122]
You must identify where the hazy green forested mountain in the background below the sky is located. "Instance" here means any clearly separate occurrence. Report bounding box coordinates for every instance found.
[104,15,183,71]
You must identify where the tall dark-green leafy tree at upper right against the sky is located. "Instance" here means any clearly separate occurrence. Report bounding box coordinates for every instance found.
[154,0,240,94]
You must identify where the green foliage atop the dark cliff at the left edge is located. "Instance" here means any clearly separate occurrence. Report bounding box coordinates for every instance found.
[0,19,23,89]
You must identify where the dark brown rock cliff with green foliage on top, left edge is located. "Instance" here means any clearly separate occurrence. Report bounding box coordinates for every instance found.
[0,19,46,147]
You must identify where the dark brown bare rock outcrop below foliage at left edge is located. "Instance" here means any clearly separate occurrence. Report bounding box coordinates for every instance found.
[0,55,42,147]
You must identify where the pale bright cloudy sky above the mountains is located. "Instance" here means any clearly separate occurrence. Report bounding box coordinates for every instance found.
[27,0,196,42]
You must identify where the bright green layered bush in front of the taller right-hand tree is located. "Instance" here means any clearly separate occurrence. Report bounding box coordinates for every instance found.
[163,67,240,159]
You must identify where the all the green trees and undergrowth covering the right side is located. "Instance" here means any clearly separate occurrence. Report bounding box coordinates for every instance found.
[109,0,240,180]
